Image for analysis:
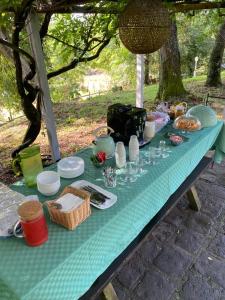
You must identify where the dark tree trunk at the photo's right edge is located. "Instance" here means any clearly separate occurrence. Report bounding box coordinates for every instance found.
[206,22,225,87]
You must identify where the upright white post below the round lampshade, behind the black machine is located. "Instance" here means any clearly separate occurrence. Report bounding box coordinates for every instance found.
[136,54,144,108]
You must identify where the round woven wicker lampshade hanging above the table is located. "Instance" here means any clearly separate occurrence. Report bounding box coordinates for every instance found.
[119,0,171,54]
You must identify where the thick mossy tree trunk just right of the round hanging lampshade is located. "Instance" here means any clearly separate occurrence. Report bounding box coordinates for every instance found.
[157,20,187,100]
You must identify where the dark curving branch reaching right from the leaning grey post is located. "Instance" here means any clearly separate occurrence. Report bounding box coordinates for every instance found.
[48,38,111,79]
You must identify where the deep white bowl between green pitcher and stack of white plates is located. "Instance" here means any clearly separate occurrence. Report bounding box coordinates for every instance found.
[37,171,60,196]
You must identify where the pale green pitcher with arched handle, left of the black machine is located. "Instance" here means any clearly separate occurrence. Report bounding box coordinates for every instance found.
[92,126,115,159]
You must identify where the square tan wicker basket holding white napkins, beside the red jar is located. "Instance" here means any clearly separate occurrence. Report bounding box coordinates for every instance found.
[46,187,91,230]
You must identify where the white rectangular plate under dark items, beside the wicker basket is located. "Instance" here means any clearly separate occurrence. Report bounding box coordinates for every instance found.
[71,180,117,209]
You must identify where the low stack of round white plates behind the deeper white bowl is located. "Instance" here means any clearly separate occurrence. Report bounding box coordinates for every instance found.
[57,156,84,178]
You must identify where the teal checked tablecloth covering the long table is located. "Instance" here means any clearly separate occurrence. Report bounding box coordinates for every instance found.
[0,122,223,300]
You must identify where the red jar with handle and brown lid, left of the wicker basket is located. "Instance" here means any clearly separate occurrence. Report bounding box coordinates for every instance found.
[14,201,48,247]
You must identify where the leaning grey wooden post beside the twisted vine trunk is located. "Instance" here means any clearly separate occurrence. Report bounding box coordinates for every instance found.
[26,12,60,161]
